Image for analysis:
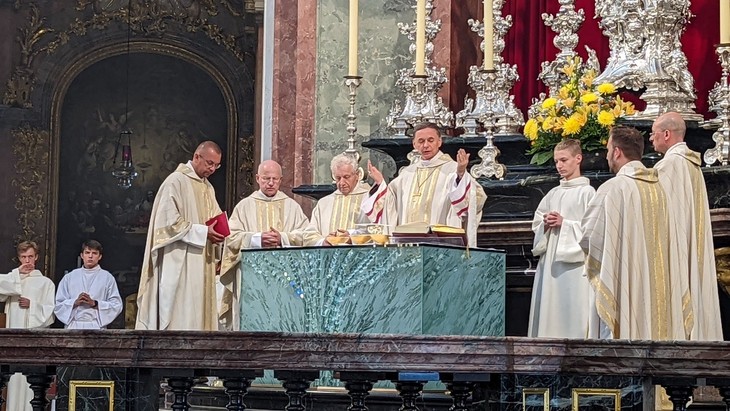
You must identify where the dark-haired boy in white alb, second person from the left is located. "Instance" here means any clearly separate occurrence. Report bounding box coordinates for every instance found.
[55,240,122,330]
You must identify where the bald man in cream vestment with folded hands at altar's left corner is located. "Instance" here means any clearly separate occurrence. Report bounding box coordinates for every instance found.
[219,160,309,329]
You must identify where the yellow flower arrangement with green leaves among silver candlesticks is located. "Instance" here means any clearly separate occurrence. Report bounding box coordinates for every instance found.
[523,56,635,165]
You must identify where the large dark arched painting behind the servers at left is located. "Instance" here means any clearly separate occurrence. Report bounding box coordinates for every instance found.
[56,53,228,326]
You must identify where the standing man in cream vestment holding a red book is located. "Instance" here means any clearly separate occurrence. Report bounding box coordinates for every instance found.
[135,141,224,331]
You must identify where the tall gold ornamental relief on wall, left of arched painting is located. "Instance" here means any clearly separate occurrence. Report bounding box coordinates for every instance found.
[11,126,51,245]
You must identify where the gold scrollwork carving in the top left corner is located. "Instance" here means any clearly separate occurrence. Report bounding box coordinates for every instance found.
[3,3,53,108]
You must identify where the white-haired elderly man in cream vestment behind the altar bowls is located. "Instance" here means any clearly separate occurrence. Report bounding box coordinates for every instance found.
[303,154,382,245]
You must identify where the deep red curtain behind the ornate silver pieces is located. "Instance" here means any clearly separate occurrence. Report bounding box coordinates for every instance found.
[500,0,721,118]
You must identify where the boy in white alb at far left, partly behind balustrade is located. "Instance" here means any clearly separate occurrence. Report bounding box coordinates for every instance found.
[0,241,56,411]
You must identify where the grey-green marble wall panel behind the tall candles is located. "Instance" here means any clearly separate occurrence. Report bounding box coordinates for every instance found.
[314,0,415,184]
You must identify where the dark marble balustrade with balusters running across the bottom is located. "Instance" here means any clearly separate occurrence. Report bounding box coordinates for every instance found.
[0,329,730,410]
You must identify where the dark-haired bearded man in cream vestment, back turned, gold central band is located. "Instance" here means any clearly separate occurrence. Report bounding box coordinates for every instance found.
[581,126,693,340]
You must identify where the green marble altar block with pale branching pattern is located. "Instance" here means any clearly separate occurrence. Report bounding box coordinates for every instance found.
[240,245,505,336]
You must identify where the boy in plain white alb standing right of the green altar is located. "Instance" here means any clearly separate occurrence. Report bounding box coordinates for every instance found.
[527,139,596,338]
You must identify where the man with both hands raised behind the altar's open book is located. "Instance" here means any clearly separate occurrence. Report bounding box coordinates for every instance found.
[366,123,487,246]
